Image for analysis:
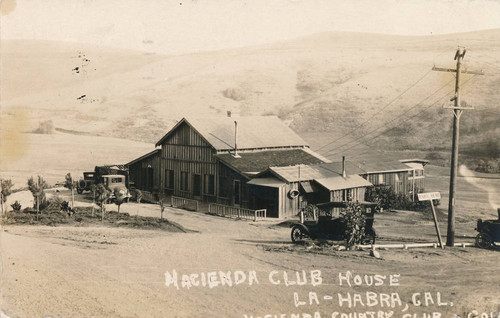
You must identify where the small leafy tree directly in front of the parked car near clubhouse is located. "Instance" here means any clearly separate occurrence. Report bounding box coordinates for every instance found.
[340,202,366,247]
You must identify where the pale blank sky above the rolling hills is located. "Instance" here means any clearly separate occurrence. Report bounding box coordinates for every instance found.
[0,0,500,54]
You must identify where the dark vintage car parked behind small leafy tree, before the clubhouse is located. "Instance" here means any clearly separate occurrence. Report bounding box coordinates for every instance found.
[290,202,377,244]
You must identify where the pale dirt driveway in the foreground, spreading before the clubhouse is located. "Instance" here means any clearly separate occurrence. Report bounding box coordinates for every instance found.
[0,193,500,318]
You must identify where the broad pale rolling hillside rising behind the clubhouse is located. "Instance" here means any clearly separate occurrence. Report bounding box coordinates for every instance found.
[1,30,500,166]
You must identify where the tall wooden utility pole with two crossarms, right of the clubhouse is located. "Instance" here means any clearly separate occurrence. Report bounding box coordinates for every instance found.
[432,47,484,246]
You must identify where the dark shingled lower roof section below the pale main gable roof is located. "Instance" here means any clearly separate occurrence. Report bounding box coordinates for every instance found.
[216,149,323,173]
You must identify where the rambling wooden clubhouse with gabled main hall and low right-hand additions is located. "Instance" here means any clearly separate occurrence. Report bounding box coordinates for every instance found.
[127,116,427,218]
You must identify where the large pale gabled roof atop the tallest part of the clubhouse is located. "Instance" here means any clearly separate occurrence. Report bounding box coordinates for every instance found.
[156,116,308,151]
